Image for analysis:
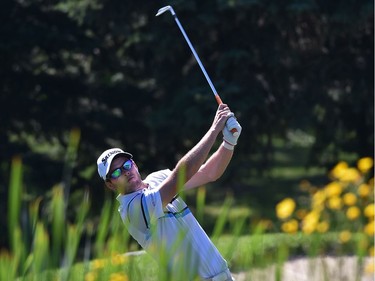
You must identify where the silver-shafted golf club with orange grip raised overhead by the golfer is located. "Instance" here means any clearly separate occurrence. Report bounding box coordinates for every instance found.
[156,6,239,136]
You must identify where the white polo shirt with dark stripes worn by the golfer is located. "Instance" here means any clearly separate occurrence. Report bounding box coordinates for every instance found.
[117,169,228,280]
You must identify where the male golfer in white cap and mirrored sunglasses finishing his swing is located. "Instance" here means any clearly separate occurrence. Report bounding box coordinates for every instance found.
[97,104,242,281]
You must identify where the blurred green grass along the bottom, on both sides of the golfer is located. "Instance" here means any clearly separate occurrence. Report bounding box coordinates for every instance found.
[0,131,374,281]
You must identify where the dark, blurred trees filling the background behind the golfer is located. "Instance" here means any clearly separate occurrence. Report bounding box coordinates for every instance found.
[0,0,374,248]
